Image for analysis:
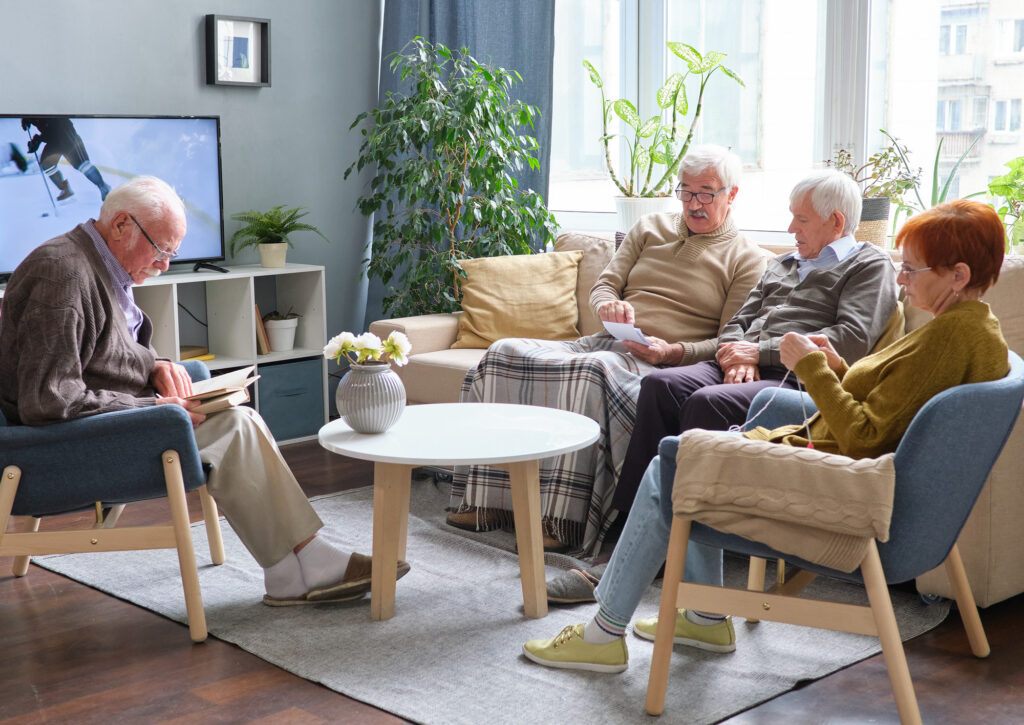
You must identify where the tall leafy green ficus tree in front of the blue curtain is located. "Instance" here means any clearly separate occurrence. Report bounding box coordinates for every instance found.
[345,38,554,316]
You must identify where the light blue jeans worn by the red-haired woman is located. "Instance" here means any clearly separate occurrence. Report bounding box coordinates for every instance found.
[594,456,722,622]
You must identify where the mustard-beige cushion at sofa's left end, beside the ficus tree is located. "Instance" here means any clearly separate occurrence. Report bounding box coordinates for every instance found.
[452,251,583,348]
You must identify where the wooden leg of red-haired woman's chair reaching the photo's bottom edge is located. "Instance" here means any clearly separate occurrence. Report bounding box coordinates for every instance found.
[860,540,921,725]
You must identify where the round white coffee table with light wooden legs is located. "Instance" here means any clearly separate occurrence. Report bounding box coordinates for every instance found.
[319,402,599,620]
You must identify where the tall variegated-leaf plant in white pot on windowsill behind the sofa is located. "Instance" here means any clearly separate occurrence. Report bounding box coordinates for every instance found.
[583,42,746,231]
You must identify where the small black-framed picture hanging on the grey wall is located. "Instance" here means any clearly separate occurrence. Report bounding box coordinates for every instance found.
[206,15,270,86]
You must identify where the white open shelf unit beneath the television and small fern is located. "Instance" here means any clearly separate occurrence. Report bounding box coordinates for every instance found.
[133,264,328,442]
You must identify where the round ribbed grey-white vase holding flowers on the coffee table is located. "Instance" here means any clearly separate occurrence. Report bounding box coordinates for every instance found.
[334,363,406,433]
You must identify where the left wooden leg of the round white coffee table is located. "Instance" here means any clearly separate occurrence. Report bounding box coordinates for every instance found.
[370,462,413,620]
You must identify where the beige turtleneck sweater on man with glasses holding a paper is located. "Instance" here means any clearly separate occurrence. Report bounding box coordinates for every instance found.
[590,212,768,365]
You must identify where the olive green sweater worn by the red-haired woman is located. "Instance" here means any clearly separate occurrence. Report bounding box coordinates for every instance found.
[745,301,1010,458]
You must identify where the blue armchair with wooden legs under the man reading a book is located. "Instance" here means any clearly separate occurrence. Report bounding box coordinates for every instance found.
[0,363,224,642]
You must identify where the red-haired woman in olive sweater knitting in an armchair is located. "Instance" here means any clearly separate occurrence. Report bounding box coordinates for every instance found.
[523,200,1010,672]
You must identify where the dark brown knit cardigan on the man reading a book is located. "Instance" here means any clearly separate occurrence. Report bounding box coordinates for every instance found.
[0,225,157,425]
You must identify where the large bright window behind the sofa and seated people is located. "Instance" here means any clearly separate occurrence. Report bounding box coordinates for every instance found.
[548,0,1024,237]
